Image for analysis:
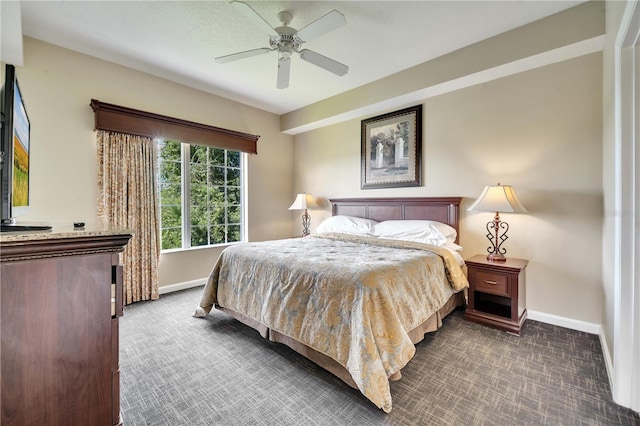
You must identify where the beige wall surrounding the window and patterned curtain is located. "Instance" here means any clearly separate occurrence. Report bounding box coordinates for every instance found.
[16,38,293,285]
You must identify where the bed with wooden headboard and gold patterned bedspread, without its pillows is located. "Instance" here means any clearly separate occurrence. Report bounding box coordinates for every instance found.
[195,197,468,412]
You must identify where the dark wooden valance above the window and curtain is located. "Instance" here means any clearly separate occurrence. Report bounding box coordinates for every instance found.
[91,99,260,154]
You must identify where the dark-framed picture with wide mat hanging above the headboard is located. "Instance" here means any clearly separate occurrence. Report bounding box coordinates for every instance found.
[361,105,422,189]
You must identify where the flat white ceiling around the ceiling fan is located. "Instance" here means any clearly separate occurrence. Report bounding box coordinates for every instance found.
[13,0,582,114]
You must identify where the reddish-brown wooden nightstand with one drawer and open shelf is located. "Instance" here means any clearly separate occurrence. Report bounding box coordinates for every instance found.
[464,255,529,334]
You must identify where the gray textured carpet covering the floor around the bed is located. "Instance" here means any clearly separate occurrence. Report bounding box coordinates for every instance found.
[120,287,640,426]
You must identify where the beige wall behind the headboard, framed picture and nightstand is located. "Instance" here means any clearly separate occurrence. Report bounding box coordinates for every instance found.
[294,53,603,324]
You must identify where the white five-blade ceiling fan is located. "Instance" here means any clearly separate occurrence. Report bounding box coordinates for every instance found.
[215,1,349,89]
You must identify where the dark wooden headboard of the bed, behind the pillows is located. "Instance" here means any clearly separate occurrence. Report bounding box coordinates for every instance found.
[329,197,462,243]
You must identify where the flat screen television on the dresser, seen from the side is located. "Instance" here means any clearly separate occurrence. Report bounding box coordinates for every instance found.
[0,64,50,231]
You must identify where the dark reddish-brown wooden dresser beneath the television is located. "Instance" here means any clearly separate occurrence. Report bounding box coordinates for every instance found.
[0,228,131,426]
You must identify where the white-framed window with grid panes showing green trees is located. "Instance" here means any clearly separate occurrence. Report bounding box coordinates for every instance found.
[158,141,244,250]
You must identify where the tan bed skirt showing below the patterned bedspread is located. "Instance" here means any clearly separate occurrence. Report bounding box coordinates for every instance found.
[214,291,465,389]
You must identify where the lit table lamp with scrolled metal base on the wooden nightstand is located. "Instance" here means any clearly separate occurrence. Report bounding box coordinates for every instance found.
[467,183,528,262]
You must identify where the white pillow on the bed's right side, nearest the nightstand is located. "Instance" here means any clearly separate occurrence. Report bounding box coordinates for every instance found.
[371,220,462,250]
